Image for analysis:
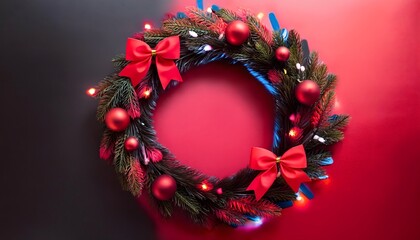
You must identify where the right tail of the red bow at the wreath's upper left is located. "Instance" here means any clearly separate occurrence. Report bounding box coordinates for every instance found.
[156,56,182,89]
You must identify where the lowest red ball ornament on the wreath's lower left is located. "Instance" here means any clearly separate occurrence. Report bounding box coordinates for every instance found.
[152,174,176,201]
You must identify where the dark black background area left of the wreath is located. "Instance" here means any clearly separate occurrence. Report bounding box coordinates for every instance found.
[0,0,164,239]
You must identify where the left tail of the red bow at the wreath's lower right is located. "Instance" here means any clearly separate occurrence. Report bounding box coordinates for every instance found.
[246,165,277,201]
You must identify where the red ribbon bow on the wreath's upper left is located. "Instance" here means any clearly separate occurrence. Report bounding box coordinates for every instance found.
[119,36,182,89]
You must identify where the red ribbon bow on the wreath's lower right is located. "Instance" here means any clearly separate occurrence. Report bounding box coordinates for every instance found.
[246,145,311,200]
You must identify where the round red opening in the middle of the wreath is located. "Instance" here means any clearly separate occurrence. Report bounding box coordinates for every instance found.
[153,62,274,178]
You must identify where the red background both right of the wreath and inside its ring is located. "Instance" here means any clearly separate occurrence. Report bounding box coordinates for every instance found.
[142,0,420,240]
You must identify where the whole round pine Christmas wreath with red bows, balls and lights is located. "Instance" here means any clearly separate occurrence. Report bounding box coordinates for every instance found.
[90,3,349,226]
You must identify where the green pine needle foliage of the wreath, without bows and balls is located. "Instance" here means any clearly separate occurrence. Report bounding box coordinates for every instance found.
[97,8,349,226]
